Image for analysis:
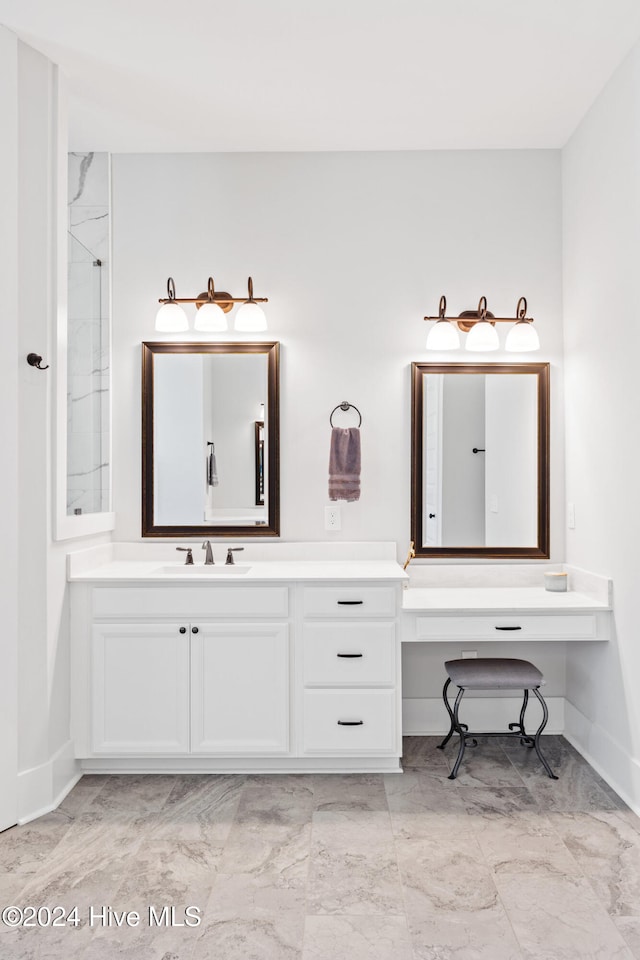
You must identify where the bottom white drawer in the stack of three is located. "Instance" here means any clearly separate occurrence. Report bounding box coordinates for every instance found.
[303,690,397,755]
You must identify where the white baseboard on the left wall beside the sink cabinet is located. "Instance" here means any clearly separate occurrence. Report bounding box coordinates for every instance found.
[18,740,82,825]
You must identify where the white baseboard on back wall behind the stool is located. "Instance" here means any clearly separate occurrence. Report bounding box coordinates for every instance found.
[402,697,565,737]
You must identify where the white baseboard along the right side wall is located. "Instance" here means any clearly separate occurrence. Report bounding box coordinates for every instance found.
[564,700,640,817]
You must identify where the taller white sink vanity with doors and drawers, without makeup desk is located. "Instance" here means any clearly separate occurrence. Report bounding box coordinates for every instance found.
[69,544,407,772]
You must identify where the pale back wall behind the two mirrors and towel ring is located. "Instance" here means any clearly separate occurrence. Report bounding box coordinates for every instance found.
[112,151,564,559]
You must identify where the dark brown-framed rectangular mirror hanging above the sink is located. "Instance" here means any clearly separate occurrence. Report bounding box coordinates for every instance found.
[142,343,279,537]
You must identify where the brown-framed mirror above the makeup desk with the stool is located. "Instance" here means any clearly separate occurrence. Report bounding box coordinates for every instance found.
[411,363,549,558]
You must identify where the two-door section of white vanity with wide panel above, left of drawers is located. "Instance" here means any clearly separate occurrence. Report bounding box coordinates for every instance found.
[72,585,291,757]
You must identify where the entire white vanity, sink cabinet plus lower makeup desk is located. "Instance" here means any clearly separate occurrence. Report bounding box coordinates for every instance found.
[68,543,612,772]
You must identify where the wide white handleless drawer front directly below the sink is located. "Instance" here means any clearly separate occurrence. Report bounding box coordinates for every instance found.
[93,584,289,620]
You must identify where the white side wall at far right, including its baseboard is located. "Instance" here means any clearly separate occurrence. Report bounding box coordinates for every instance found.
[563,37,640,808]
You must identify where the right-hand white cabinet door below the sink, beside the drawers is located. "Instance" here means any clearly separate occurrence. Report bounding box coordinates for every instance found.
[191,623,289,755]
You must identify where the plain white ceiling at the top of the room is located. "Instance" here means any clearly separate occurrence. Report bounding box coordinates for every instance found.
[0,0,640,153]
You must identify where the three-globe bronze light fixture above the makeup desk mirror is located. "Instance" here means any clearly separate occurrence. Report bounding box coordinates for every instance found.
[424,297,540,353]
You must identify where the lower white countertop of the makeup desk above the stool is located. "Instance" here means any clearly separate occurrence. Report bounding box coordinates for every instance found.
[402,587,612,614]
